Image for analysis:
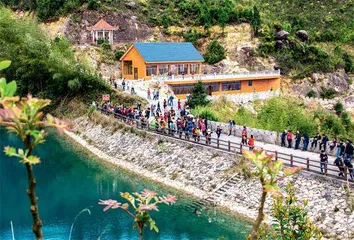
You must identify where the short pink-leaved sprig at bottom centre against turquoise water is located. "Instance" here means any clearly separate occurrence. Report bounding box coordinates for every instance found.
[98,189,177,240]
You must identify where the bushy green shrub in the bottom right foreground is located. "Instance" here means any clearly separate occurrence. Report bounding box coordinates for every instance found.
[258,183,322,240]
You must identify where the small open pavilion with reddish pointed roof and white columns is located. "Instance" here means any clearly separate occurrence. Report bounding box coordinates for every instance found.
[87,16,118,44]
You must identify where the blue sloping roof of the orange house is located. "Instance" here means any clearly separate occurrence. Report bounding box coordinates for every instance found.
[134,42,204,62]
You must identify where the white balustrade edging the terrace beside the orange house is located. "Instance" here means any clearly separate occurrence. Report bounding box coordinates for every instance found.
[151,70,280,81]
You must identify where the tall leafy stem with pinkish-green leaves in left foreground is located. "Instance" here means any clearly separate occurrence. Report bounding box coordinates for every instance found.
[0,61,67,239]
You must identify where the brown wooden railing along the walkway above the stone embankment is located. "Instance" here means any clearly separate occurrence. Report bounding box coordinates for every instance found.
[97,107,354,182]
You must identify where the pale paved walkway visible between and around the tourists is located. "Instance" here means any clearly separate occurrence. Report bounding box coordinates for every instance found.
[112,82,338,178]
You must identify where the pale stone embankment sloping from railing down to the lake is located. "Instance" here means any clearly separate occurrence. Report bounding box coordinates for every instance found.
[70,116,354,239]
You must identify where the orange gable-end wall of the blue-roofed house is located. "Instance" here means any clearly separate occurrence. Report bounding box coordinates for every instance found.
[122,46,146,80]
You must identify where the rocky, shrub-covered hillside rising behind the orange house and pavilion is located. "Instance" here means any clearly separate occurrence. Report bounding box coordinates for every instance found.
[2,0,354,100]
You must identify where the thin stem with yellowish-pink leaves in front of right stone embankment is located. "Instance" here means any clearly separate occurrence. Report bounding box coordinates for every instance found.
[243,150,301,240]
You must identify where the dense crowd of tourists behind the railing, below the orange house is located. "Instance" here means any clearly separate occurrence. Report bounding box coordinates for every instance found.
[97,96,255,150]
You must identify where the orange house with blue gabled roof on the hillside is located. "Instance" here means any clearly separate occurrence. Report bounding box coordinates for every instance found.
[120,42,204,80]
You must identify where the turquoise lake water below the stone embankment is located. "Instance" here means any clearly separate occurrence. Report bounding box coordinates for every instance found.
[0,130,250,240]
